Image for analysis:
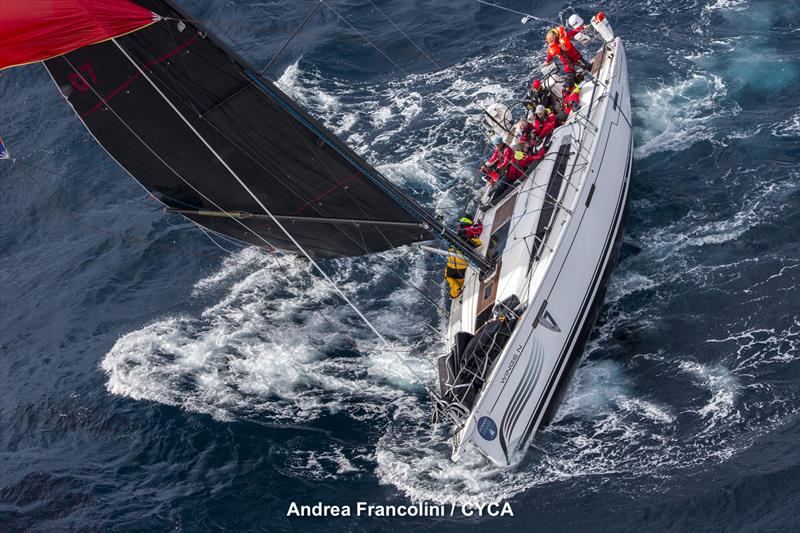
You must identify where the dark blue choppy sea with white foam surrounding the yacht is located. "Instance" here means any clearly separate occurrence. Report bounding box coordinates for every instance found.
[0,0,800,531]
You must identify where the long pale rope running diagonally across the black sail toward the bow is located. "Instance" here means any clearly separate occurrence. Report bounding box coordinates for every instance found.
[105,39,438,394]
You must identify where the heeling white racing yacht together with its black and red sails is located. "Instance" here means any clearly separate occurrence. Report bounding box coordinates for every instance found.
[0,0,631,465]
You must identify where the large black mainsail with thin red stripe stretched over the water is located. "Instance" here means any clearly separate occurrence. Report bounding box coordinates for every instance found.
[45,0,432,258]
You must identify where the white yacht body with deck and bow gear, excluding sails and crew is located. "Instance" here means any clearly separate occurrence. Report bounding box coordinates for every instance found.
[439,13,633,466]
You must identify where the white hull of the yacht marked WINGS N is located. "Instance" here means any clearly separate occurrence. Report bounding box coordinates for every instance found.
[448,39,632,465]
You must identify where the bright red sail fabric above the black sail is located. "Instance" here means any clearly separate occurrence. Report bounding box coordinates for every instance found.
[0,0,158,70]
